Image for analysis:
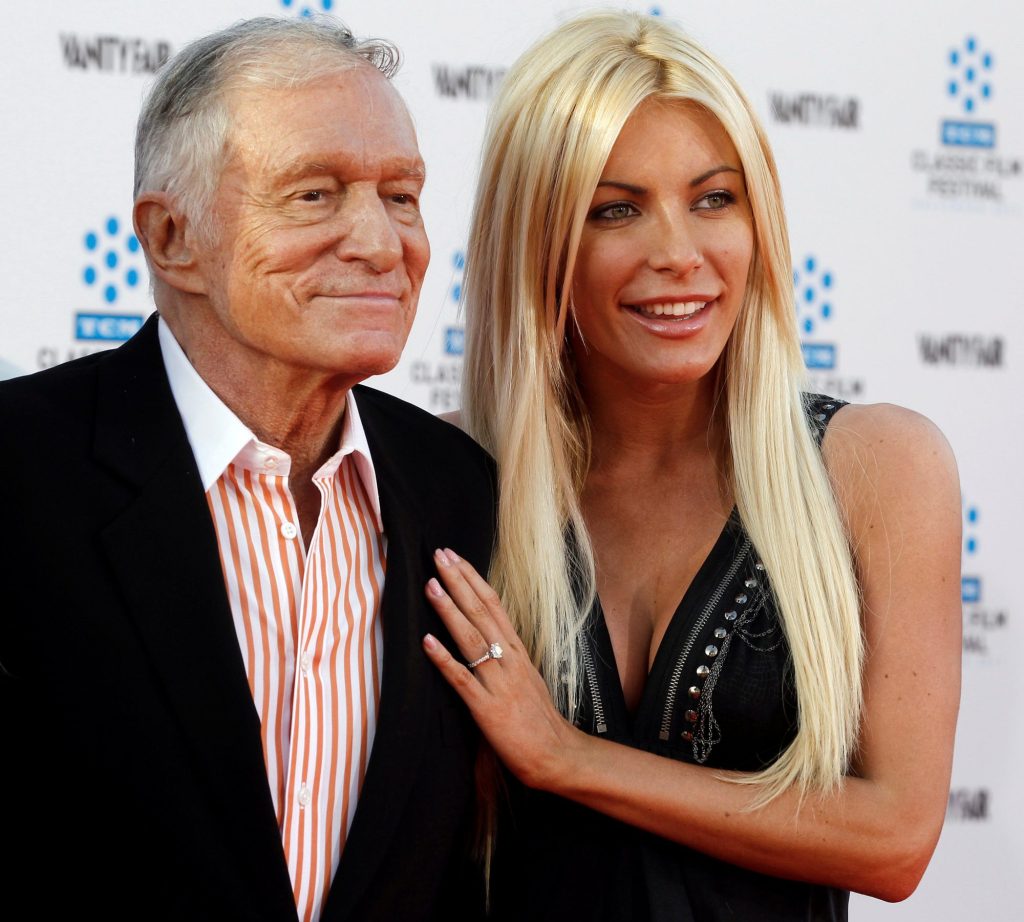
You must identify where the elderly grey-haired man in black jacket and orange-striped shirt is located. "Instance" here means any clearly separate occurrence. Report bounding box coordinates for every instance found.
[0,19,494,922]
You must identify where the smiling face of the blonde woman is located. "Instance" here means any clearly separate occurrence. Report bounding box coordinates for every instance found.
[572,99,754,397]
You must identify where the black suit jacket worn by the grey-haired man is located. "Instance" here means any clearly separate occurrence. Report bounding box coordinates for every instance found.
[0,320,494,922]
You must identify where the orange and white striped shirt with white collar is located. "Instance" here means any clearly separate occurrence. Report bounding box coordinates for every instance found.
[160,322,385,922]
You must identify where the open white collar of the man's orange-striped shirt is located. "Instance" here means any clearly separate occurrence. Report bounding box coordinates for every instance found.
[157,318,384,532]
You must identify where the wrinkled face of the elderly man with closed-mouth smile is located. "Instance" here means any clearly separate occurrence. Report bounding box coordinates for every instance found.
[197,64,430,381]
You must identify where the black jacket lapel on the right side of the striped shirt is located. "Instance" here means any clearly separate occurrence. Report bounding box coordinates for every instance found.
[323,390,436,922]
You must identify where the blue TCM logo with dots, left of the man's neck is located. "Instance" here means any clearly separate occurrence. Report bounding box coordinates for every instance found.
[75,216,142,342]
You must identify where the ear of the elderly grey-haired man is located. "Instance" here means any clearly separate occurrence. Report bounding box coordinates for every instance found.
[132,192,207,294]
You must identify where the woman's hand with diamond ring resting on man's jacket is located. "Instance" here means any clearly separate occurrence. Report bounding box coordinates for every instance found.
[423,549,588,788]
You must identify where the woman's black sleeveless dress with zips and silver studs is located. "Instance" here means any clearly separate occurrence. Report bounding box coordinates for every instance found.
[490,395,849,922]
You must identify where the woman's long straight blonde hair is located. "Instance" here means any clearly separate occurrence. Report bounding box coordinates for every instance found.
[463,12,862,803]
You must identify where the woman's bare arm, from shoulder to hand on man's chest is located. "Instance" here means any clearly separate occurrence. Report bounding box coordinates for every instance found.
[425,406,962,899]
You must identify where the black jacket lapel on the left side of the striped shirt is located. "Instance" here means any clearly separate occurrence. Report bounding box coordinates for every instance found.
[95,319,295,918]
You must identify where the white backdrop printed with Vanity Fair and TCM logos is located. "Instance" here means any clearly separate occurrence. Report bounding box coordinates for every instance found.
[0,0,1024,922]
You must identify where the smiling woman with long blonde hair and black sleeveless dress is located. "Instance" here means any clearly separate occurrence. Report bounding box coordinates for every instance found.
[424,12,961,922]
